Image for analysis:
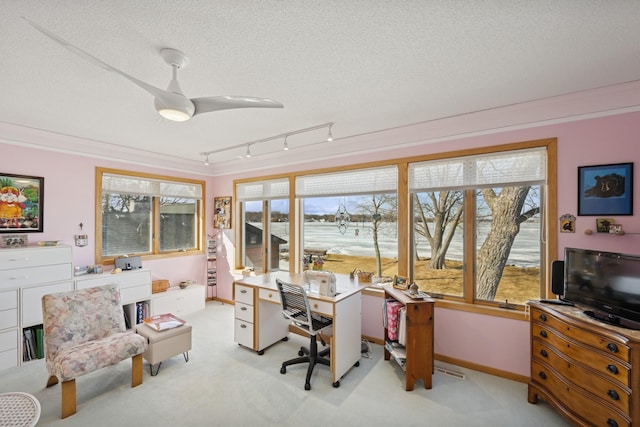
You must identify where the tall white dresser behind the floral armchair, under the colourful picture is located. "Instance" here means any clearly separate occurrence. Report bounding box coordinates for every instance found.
[0,246,73,369]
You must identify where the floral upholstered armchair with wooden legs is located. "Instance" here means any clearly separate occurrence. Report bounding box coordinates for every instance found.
[42,285,147,418]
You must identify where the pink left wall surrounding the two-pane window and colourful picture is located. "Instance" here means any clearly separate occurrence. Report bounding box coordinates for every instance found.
[0,144,218,296]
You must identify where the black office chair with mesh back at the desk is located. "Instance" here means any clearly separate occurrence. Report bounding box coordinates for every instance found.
[276,279,333,390]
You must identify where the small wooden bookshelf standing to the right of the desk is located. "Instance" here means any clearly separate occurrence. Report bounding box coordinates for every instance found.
[384,286,435,391]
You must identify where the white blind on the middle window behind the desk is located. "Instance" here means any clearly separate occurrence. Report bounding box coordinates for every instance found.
[296,166,398,197]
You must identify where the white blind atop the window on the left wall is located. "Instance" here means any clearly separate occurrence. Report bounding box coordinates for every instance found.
[102,173,202,199]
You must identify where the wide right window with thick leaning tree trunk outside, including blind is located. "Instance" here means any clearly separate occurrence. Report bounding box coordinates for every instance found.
[409,148,546,304]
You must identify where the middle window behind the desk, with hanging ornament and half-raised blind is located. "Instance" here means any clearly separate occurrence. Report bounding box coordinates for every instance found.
[296,165,398,276]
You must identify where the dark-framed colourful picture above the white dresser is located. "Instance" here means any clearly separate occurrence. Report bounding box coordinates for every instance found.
[0,173,44,233]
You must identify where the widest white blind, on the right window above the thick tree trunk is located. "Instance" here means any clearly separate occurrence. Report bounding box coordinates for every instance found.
[409,148,547,192]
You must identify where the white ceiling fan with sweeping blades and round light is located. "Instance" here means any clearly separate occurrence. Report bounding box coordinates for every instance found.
[23,17,283,122]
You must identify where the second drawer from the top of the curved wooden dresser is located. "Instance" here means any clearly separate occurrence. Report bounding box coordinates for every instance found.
[531,324,631,387]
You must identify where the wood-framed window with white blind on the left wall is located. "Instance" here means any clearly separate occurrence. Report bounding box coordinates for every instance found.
[96,168,204,262]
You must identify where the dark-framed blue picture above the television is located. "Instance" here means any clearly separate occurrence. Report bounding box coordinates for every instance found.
[578,163,633,215]
